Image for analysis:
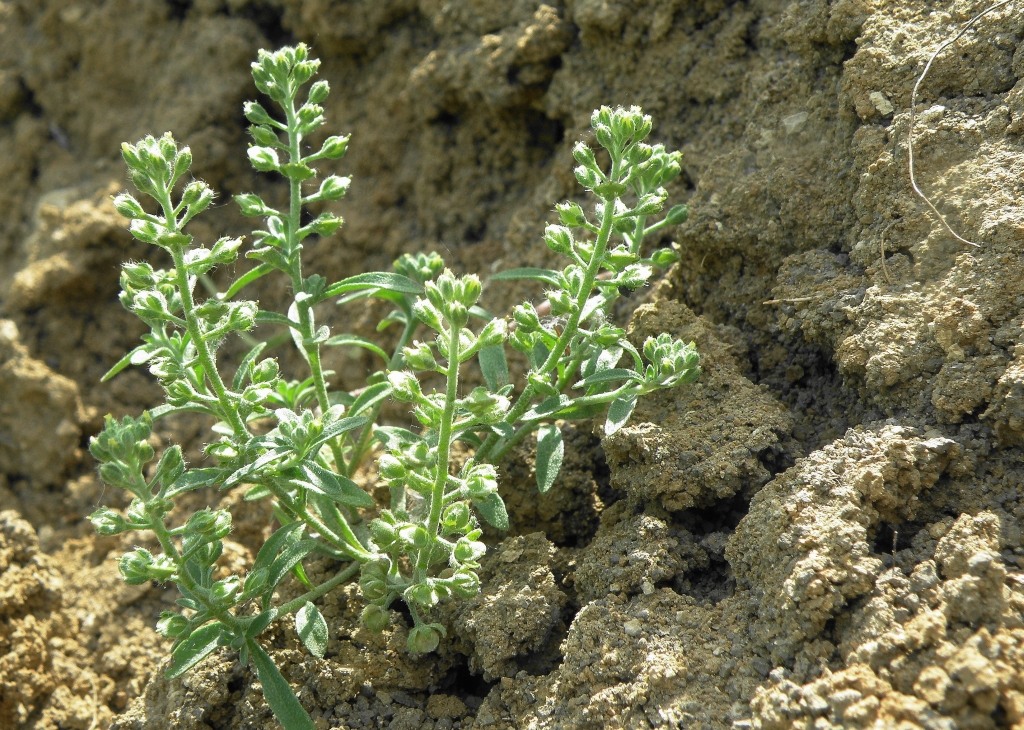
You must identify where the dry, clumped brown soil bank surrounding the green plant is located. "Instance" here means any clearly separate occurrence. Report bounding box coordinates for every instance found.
[0,0,1024,730]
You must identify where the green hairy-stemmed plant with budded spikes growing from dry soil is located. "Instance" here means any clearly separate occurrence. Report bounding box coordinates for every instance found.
[90,45,698,728]
